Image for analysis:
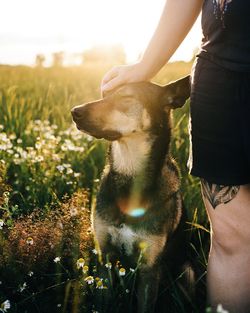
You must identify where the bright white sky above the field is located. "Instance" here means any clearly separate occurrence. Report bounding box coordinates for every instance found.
[0,0,201,65]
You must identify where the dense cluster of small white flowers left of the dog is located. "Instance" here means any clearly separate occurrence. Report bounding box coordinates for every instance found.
[0,120,103,211]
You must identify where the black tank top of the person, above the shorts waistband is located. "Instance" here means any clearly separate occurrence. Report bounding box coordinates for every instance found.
[198,0,250,72]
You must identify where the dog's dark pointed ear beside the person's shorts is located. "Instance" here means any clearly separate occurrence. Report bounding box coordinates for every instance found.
[162,75,190,109]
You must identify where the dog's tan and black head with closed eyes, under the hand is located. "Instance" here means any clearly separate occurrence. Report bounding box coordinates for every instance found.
[71,76,190,141]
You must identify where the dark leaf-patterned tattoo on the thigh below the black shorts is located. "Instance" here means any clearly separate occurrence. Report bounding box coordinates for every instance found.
[201,179,240,209]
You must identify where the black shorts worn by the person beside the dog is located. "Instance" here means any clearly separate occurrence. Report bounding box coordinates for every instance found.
[189,58,250,185]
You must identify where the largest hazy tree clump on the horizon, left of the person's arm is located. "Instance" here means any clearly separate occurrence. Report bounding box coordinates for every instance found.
[82,44,126,64]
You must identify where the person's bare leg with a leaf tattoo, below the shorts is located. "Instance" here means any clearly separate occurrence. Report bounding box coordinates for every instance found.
[202,180,250,313]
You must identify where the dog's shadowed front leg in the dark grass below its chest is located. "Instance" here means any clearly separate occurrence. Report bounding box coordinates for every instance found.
[137,266,160,313]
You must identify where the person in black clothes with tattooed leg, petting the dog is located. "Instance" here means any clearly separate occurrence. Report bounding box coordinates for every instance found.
[101,0,250,313]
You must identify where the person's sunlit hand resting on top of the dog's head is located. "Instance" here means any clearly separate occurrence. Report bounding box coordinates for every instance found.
[101,63,147,92]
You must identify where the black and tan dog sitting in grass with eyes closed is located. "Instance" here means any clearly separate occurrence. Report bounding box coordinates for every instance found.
[71,76,193,313]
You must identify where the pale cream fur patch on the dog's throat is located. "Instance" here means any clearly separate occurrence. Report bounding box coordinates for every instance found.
[110,133,152,177]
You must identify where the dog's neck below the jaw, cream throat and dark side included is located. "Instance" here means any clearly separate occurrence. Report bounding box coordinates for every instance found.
[109,127,170,182]
